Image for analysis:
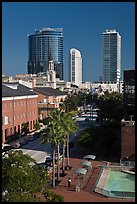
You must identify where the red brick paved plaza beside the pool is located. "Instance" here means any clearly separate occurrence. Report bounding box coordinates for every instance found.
[51,158,135,202]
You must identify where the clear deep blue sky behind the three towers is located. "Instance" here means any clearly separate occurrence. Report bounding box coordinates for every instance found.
[2,2,135,82]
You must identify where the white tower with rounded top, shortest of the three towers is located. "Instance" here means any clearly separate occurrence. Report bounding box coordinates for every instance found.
[69,48,82,85]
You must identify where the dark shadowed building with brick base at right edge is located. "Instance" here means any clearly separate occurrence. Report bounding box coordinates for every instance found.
[121,70,135,161]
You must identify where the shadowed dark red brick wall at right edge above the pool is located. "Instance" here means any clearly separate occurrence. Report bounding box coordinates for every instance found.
[121,125,135,158]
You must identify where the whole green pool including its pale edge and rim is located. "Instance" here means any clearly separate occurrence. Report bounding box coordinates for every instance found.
[94,167,135,199]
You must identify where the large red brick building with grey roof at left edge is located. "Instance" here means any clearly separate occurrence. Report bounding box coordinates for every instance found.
[2,83,38,143]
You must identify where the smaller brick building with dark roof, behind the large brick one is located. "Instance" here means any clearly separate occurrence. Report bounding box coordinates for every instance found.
[33,87,67,119]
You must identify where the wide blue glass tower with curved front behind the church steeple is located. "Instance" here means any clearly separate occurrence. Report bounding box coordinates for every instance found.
[28,28,63,80]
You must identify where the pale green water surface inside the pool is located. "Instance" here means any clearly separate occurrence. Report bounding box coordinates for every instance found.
[104,170,135,196]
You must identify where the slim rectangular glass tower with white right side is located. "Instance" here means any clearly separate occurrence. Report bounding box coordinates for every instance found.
[103,30,121,84]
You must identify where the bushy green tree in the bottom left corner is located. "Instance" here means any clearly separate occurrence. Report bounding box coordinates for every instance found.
[2,150,49,202]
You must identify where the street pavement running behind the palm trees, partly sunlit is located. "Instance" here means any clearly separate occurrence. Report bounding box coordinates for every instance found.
[15,113,96,163]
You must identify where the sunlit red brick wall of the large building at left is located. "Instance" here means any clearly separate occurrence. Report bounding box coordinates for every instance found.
[2,97,38,143]
